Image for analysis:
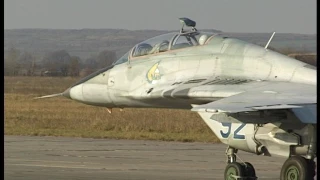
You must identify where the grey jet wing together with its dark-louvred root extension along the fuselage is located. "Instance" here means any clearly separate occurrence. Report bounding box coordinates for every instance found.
[156,81,317,123]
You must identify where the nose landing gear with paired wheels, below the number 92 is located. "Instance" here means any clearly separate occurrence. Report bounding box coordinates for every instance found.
[224,147,257,180]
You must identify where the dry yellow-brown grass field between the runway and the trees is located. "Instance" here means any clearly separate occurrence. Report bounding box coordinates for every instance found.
[4,77,219,142]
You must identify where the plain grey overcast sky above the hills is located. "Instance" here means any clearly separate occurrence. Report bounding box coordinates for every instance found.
[4,0,317,34]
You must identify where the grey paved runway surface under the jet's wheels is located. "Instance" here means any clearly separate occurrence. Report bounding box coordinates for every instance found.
[4,136,286,180]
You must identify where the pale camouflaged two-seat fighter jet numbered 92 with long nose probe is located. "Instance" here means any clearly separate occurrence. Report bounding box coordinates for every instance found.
[36,18,317,180]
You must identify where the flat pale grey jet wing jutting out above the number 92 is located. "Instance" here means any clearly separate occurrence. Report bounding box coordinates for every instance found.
[192,82,317,123]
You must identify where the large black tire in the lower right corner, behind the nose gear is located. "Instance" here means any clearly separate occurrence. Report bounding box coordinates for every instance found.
[280,156,315,180]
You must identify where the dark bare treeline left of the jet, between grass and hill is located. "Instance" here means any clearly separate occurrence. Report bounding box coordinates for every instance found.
[4,48,117,77]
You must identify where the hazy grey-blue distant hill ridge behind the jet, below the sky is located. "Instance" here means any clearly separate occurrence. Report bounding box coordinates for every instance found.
[4,29,317,59]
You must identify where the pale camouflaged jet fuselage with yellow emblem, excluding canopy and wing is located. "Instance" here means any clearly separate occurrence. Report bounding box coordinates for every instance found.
[64,32,316,109]
